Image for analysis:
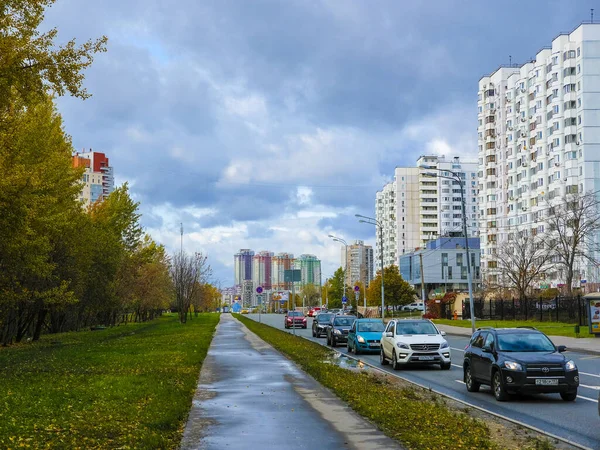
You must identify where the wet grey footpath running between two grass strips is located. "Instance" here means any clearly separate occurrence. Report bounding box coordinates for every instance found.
[181,314,401,450]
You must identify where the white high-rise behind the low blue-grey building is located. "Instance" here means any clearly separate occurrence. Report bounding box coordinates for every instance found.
[375,155,478,267]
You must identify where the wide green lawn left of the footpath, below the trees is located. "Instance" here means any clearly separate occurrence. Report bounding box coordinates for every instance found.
[0,314,219,449]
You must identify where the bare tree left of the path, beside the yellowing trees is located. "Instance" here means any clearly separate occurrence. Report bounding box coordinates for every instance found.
[171,252,212,323]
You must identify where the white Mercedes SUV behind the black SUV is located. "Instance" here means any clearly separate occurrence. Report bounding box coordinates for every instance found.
[379,319,451,370]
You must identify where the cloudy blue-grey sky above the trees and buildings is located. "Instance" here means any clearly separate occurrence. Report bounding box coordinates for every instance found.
[43,0,600,287]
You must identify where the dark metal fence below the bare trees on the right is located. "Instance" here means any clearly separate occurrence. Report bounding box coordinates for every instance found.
[460,296,588,325]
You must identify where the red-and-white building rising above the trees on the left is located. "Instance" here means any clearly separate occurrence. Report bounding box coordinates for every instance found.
[72,149,115,206]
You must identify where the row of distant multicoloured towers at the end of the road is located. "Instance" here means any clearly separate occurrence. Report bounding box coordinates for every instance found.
[233,249,321,306]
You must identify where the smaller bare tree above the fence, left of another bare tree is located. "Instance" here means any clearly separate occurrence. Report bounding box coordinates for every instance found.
[496,230,551,300]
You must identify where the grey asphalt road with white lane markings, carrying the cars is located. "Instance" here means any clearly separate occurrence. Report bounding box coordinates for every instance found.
[248,314,600,450]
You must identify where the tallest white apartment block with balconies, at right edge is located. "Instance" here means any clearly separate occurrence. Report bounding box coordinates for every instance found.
[478,24,600,284]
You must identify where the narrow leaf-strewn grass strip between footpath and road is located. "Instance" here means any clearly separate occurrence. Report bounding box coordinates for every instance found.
[235,314,497,449]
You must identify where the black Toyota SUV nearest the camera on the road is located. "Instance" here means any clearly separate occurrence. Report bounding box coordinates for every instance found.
[463,328,579,401]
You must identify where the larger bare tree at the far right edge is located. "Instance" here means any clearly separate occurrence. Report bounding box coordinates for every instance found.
[546,192,600,295]
